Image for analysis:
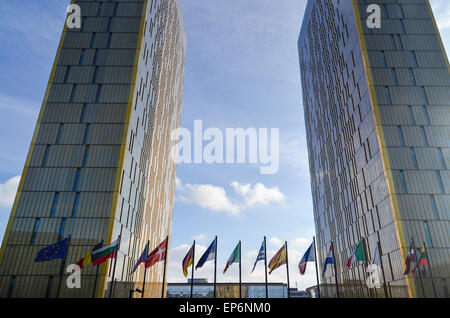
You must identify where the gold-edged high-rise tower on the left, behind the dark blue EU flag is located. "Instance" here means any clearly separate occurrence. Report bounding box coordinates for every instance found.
[0,0,186,297]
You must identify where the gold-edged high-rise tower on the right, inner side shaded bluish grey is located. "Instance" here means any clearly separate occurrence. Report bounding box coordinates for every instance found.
[298,0,450,297]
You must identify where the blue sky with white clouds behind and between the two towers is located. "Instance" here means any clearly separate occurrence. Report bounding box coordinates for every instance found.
[0,0,450,289]
